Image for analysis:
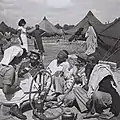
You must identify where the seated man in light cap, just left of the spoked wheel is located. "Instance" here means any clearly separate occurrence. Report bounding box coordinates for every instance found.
[18,50,44,93]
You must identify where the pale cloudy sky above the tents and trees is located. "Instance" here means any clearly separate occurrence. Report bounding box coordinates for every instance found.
[0,0,120,27]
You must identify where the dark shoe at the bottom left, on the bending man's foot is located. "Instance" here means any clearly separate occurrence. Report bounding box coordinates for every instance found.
[10,104,27,120]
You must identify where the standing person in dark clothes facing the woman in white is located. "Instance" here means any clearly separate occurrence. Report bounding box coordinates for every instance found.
[32,24,45,54]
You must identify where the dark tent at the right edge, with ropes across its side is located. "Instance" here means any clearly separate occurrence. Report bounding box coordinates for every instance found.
[95,18,120,66]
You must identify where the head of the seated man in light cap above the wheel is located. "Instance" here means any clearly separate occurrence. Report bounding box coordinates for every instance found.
[29,50,40,63]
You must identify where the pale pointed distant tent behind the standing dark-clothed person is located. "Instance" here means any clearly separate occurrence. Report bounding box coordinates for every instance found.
[39,17,62,35]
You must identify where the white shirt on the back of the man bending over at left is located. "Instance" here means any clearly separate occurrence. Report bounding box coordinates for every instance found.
[0,45,23,65]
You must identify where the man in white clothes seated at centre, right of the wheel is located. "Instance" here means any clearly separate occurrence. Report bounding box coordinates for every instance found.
[47,50,76,97]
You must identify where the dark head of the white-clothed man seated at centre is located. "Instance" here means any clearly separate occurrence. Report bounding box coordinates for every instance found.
[57,50,69,64]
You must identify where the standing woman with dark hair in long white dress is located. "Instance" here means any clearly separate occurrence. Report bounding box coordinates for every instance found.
[18,19,28,52]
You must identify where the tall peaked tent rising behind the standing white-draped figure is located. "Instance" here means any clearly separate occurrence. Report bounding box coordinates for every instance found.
[65,11,106,41]
